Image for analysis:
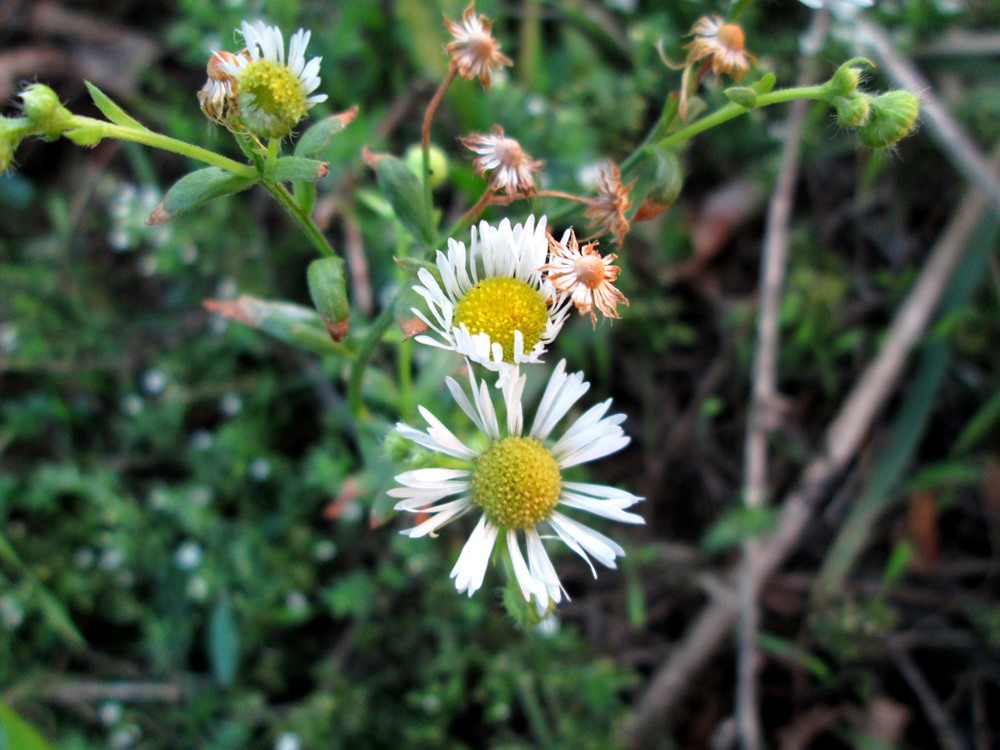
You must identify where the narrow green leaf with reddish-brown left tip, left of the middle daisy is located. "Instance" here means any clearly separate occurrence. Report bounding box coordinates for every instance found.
[202,295,346,355]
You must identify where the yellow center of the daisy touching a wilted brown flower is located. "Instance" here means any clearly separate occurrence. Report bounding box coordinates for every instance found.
[455,277,548,364]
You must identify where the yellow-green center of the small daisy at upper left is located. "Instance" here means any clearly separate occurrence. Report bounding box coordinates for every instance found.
[239,59,309,138]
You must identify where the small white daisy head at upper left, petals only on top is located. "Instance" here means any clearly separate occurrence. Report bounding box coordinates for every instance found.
[219,21,327,138]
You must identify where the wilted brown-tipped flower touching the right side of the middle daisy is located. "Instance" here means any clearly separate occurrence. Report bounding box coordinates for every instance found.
[539,230,628,328]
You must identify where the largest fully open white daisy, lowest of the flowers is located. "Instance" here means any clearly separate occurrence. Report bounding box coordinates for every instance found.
[389,360,645,616]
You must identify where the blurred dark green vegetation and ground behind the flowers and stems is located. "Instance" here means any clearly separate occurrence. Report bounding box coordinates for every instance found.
[0,0,1000,750]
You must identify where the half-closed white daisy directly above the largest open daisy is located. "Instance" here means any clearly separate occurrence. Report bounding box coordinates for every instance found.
[413,216,569,381]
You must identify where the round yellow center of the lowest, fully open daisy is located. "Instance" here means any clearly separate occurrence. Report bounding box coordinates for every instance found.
[472,436,562,529]
